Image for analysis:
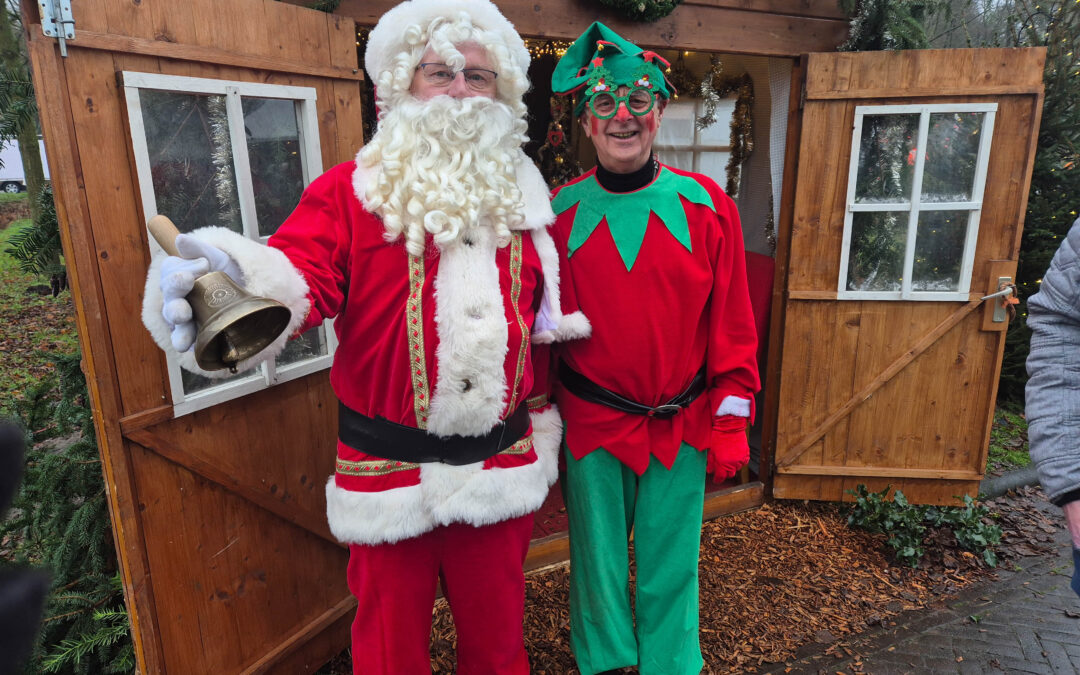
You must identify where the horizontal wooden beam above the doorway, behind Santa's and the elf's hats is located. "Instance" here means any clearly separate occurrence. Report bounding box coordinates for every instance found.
[328,0,848,57]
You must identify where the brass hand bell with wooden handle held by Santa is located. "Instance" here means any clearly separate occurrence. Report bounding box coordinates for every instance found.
[147,216,292,373]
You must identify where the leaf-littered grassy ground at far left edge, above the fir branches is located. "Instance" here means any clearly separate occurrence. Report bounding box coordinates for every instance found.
[0,220,79,417]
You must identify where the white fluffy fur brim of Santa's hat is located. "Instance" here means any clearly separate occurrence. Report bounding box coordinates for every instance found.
[364,0,529,82]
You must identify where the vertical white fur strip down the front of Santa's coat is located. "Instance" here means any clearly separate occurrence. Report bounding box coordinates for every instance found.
[428,227,508,436]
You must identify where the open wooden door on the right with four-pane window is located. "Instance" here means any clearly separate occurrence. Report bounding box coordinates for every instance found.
[767,50,1044,503]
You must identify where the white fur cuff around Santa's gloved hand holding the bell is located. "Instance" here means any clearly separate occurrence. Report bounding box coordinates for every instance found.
[143,227,310,378]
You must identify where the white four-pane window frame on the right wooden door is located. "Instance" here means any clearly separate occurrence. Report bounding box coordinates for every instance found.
[837,103,998,301]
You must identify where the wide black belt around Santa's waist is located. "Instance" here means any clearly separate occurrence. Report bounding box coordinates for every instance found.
[338,401,529,467]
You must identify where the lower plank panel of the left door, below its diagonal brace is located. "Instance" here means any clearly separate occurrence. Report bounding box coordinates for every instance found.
[133,446,349,673]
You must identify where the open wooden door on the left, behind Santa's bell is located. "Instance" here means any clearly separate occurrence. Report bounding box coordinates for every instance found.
[22,0,363,674]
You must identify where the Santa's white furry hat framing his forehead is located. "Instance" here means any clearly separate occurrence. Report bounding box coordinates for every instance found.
[364,0,530,104]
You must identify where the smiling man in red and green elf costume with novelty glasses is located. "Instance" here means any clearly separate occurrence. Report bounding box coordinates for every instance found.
[552,23,759,675]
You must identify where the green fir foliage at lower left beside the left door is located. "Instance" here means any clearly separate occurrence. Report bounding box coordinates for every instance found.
[0,353,134,675]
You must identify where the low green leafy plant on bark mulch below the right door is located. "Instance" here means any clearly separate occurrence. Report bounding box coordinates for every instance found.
[846,484,1001,567]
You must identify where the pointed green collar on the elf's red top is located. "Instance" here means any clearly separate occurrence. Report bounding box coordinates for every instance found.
[551,166,716,272]
